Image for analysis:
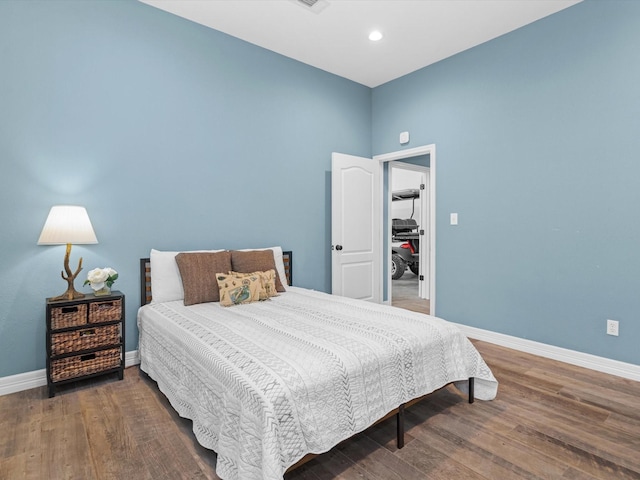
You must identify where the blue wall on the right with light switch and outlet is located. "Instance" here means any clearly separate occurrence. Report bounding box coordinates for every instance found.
[373,0,640,364]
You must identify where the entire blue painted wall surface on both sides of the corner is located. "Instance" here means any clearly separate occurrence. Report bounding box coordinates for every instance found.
[0,0,640,377]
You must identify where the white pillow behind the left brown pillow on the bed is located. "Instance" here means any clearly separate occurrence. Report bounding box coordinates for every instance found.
[149,249,224,303]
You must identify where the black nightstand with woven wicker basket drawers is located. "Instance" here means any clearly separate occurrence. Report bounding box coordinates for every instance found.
[46,291,125,397]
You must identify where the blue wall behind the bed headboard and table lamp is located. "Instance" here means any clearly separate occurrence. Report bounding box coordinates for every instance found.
[0,0,371,377]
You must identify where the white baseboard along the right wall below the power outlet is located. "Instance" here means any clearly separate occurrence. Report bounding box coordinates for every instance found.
[456,323,640,381]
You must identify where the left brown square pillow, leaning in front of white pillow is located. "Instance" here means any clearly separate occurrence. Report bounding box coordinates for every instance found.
[176,252,231,305]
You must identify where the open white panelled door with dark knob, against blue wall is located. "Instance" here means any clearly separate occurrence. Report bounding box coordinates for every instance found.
[331,153,382,303]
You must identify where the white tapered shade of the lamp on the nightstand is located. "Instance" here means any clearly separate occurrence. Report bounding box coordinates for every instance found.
[38,205,98,245]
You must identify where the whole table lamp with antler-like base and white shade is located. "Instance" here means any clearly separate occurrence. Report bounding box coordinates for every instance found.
[38,205,98,301]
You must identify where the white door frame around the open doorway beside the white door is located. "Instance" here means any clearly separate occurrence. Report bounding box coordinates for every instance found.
[373,144,436,316]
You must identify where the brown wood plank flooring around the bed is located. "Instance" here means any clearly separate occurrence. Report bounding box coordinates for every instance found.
[0,342,640,480]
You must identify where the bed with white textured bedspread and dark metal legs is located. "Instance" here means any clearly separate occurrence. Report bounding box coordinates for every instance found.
[138,247,498,480]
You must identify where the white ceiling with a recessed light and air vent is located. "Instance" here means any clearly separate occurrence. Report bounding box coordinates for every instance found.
[140,0,581,87]
